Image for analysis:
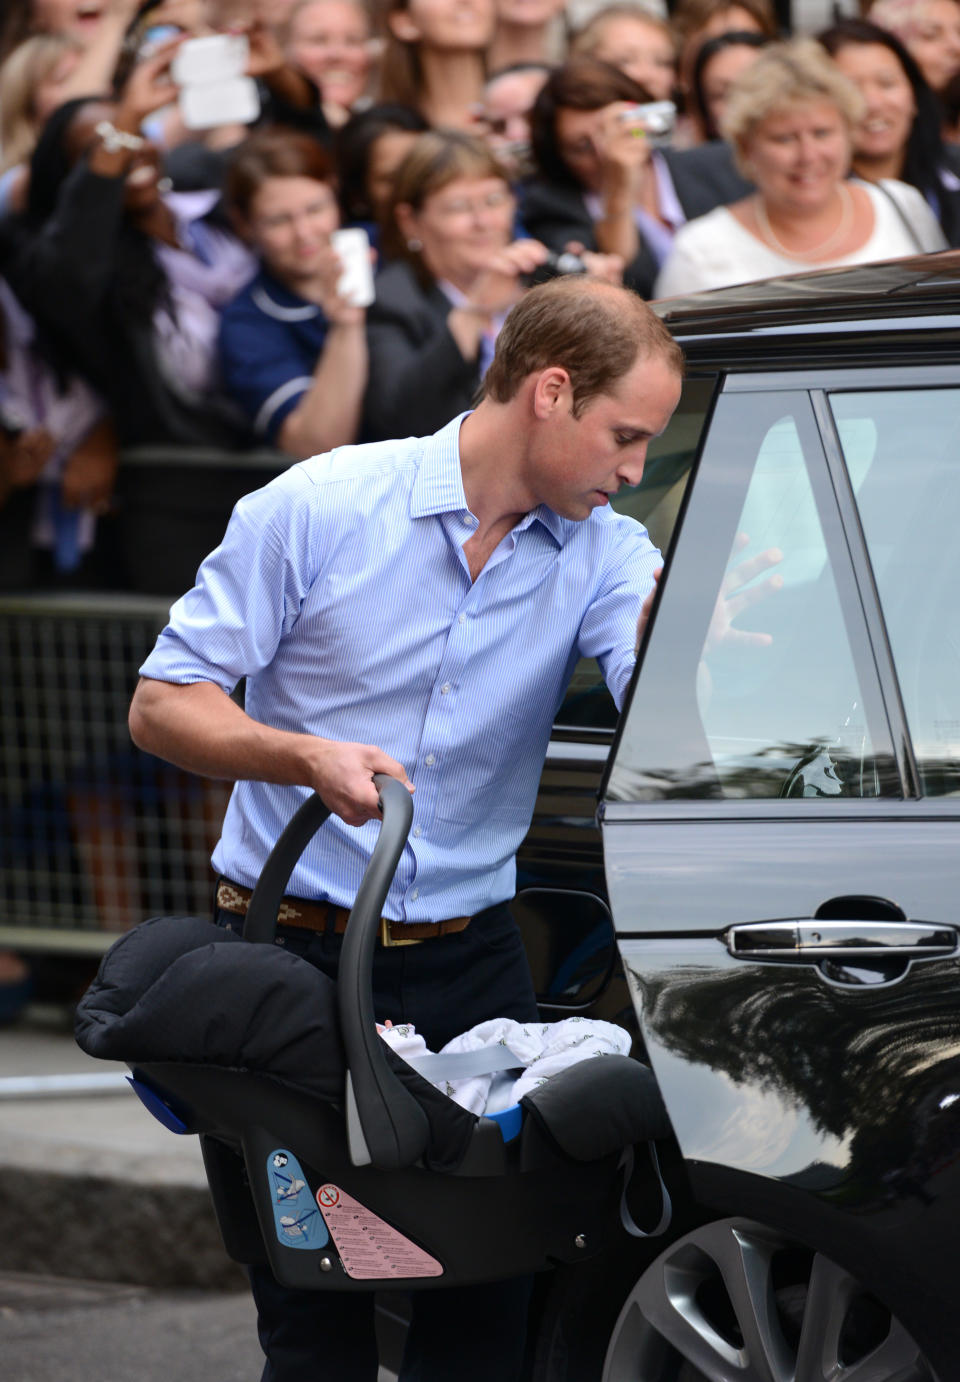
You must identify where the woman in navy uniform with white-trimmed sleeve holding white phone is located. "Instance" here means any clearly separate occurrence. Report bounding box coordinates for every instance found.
[220,127,366,459]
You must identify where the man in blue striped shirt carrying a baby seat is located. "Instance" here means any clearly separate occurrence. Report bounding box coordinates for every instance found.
[130,278,682,1382]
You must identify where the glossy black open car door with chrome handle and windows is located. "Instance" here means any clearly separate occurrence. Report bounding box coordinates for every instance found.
[601,369,960,1359]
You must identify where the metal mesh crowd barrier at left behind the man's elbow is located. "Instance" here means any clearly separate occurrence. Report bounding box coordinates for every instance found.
[0,594,229,954]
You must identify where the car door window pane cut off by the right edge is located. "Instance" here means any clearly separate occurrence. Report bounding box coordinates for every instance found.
[830,388,960,796]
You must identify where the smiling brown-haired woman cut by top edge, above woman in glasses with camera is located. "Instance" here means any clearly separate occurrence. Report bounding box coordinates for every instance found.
[378,0,496,130]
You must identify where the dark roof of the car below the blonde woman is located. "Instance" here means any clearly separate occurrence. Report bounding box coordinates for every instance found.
[651,250,960,368]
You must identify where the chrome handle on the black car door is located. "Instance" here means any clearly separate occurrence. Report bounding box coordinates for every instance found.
[724,918,957,965]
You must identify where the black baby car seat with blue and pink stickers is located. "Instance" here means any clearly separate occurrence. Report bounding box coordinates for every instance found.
[76,777,670,1291]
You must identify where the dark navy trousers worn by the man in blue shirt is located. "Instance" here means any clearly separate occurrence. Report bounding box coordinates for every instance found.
[217,904,537,1382]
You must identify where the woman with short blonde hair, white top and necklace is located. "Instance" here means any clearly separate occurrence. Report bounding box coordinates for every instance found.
[656,39,946,297]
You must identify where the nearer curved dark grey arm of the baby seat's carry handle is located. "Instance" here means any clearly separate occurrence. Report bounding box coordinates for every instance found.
[337,773,428,1169]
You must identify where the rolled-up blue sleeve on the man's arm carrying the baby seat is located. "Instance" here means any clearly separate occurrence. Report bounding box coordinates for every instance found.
[140,466,316,695]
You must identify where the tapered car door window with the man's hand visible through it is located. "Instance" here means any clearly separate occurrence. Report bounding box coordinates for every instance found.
[609,394,899,800]
